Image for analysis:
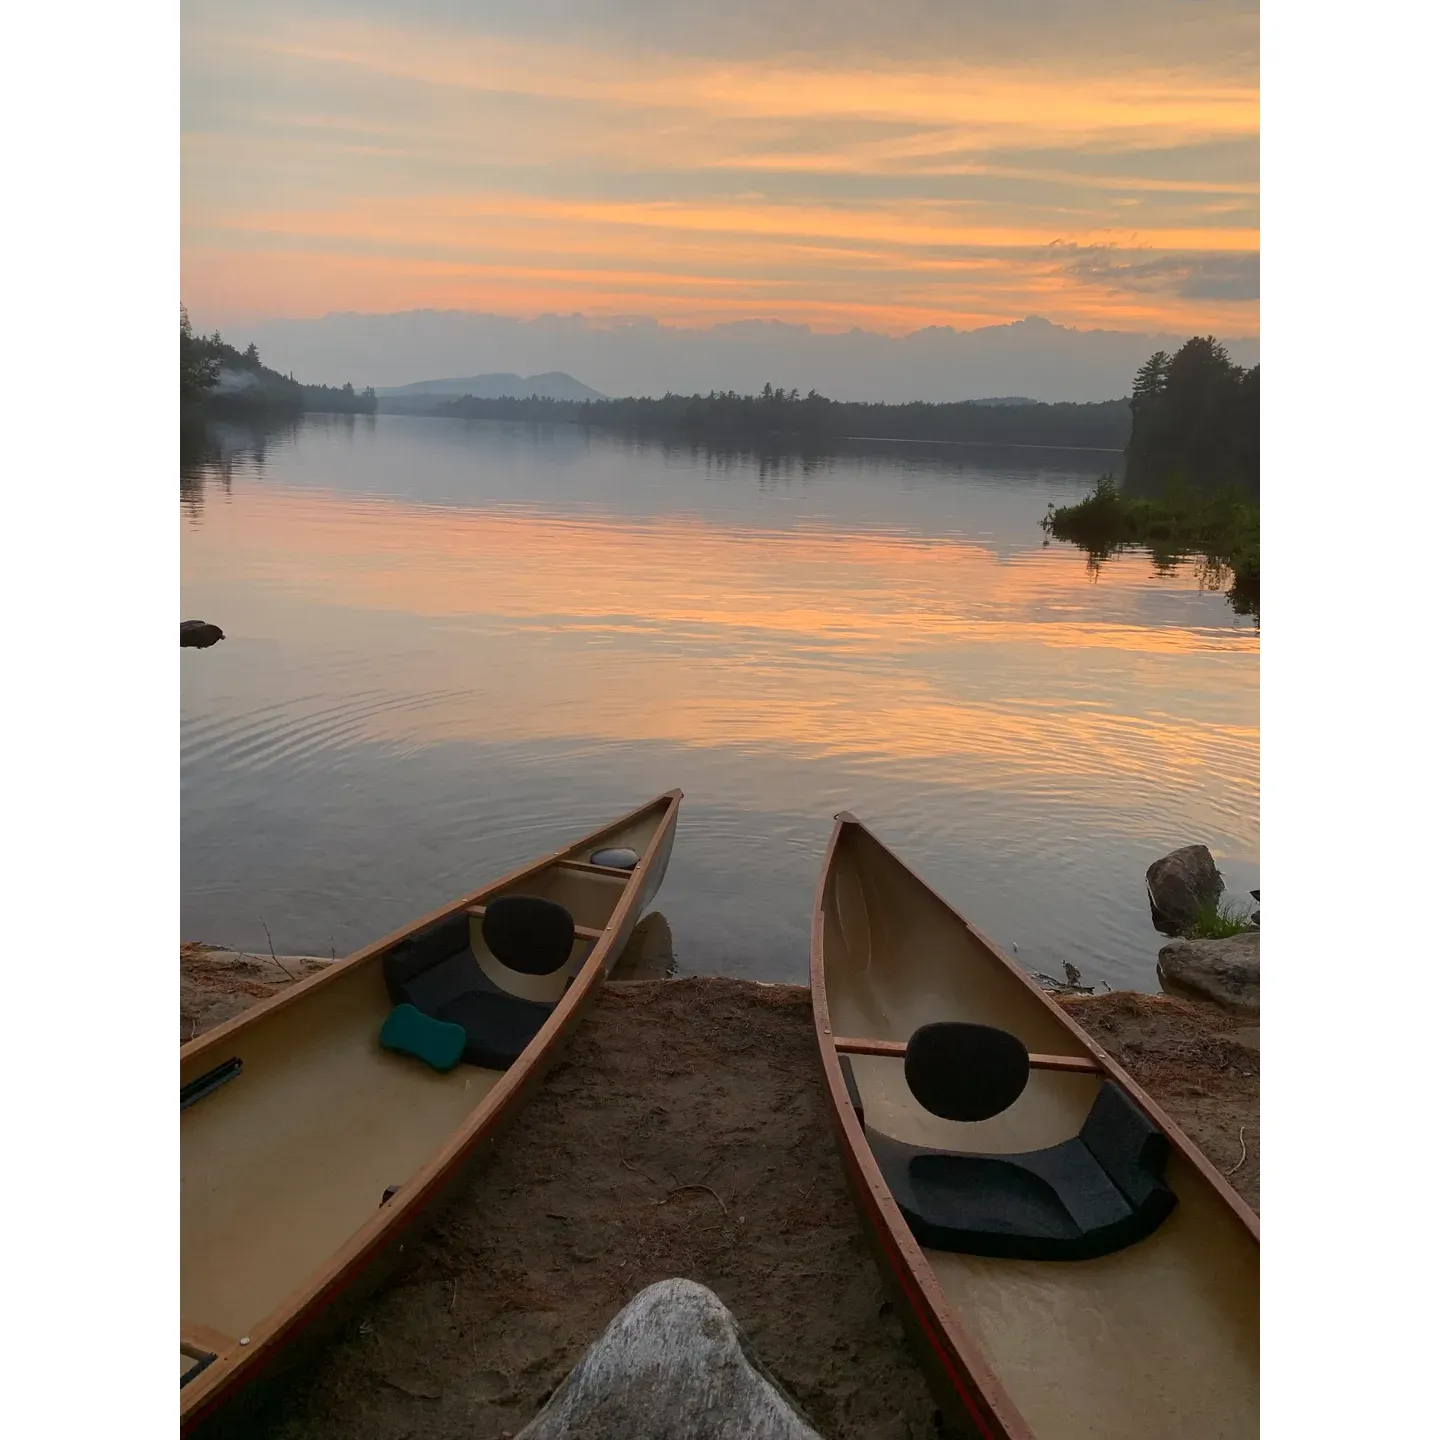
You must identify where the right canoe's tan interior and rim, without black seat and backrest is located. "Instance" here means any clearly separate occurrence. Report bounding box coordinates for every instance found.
[811,814,1260,1440]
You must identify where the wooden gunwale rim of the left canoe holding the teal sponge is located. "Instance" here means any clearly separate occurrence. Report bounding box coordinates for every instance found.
[180,789,684,1434]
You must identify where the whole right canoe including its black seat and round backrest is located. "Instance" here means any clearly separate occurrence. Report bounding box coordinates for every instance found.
[811,814,1260,1440]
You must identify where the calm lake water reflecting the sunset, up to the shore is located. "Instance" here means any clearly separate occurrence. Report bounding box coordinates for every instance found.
[180,416,1260,989]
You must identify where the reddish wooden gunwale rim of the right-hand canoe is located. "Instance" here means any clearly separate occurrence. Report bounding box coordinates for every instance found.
[811,811,1260,1440]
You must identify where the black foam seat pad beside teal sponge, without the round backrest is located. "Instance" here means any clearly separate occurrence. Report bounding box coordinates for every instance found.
[383,917,554,1070]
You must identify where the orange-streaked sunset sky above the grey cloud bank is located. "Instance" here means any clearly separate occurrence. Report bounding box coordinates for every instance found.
[181,0,1259,336]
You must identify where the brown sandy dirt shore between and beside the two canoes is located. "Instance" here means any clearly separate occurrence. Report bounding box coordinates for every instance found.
[181,938,1260,1440]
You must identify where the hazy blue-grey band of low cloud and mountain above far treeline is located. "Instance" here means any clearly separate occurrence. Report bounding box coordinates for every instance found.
[216,310,1260,406]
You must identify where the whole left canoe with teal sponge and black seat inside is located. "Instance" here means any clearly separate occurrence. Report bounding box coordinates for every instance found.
[180,791,681,1434]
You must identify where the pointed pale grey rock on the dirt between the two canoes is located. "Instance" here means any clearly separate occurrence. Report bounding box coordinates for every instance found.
[516,1280,821,1440]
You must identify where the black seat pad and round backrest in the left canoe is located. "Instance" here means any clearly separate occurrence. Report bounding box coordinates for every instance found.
[383,896,575,1070]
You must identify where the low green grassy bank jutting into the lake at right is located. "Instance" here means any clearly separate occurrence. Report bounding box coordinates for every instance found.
[1040,475,1260,615]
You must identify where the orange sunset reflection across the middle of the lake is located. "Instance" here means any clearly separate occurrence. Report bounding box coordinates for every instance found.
[186,491,1259,825]
